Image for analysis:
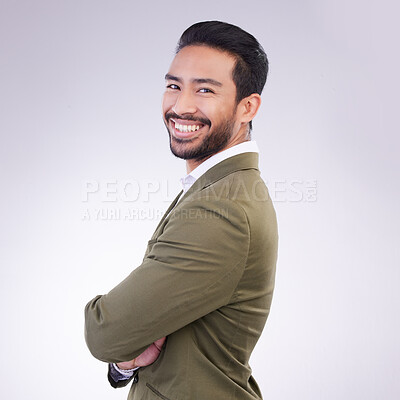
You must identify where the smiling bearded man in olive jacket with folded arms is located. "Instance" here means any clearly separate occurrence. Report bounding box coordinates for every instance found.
[85,21,278,400]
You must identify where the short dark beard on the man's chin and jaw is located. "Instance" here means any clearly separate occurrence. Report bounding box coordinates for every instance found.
[166,111,235,162]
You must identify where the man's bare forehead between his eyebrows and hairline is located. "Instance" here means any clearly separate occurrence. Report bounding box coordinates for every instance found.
[169,46,235,84]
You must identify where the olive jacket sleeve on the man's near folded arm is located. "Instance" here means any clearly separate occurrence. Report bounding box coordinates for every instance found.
[85,198,250,363]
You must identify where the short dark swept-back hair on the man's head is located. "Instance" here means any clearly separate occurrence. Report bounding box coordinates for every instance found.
[176,21,268,130]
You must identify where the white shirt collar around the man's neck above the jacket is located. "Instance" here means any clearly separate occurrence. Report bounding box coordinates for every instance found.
[181,140,259,193]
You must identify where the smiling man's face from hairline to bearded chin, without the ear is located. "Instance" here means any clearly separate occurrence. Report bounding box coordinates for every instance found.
[162,46,240,161]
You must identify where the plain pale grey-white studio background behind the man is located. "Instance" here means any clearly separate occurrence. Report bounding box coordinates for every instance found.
[0,0,400,400]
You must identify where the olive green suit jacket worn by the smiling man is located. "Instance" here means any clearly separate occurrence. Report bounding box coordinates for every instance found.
[85,153,278,400]
